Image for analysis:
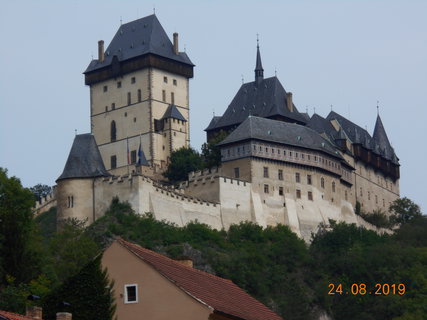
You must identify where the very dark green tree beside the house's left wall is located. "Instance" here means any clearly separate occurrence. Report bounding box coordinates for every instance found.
[43,255,115,320]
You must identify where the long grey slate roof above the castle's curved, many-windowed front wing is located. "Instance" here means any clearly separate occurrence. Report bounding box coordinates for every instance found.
[218,116,343,159]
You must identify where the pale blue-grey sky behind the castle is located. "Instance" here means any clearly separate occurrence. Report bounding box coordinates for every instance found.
[0,0,427,213]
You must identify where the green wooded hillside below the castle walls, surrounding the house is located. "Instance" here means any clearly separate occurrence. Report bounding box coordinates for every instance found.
[0,168,427,320]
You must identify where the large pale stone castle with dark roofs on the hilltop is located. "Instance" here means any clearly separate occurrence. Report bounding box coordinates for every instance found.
[35,15,399,241]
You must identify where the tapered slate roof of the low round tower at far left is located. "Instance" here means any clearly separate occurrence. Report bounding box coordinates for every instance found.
[56,133,110,181]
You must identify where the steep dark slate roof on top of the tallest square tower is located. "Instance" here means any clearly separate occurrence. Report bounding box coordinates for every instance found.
[84,14,194,73]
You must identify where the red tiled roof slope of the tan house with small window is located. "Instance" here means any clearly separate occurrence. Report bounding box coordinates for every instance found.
[117,239,283,320]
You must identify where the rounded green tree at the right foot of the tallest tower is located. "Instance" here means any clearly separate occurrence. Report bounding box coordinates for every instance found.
[163,147,203,183]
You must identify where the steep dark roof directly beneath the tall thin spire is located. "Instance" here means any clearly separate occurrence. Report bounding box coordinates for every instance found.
[210,77,307,130]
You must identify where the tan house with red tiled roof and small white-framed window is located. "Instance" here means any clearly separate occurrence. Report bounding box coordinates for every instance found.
[102,239,282,320]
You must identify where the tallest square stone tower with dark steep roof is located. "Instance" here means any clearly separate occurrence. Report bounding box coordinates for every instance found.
[84,15,194,174]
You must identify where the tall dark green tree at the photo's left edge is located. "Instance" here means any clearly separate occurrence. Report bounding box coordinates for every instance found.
[0,168,41,284]
